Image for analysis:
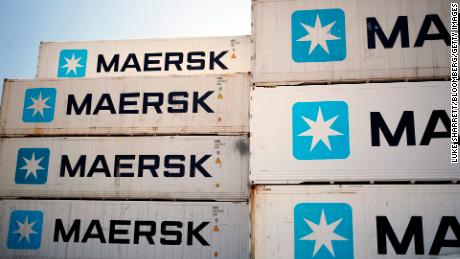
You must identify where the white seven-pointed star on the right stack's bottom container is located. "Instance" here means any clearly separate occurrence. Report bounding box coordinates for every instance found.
[300,210,348,257]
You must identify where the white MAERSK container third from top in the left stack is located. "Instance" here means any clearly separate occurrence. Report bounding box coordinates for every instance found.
[0,136,249,200]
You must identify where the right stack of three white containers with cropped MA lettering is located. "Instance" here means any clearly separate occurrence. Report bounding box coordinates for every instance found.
[250,0,460,259]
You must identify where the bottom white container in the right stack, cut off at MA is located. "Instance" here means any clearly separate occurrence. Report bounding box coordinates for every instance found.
[251,185,460,259]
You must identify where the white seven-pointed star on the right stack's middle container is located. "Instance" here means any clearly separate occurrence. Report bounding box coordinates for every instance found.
[298,107,343,151]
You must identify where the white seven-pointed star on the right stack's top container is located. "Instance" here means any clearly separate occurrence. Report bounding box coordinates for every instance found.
[297,15,341,55]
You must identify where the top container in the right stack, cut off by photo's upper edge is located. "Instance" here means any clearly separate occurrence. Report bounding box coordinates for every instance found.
[252,0,451,86]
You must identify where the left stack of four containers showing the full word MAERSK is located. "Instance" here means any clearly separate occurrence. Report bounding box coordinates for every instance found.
[0,37,250,258]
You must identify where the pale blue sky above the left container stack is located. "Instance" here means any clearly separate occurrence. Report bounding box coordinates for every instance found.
[0,0,251,102]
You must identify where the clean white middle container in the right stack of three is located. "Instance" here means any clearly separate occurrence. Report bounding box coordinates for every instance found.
[250,81,460,184]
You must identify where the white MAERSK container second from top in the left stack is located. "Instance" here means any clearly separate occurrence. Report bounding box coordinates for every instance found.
[0,74,250,136]
